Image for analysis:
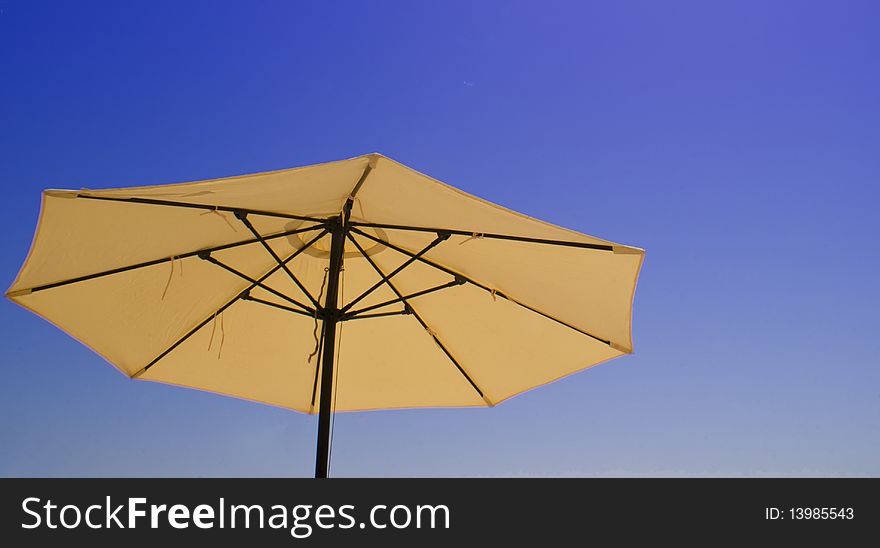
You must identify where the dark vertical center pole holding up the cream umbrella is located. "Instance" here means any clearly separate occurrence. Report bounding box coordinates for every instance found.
[315,218,346,478]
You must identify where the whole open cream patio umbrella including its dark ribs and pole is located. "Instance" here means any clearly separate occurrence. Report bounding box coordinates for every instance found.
[6,154,644,477]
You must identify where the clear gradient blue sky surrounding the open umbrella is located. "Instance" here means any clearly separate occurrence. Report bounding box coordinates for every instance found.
[0,0,880,476]
